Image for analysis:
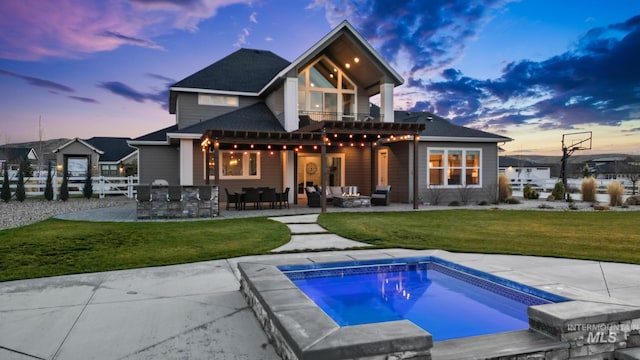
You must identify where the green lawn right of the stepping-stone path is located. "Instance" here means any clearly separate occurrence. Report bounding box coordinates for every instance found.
[319,210,640,264]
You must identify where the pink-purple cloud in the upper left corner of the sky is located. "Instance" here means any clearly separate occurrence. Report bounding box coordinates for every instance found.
[0,0,251,61]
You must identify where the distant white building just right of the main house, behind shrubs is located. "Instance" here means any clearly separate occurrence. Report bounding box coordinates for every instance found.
[499,156,551,188]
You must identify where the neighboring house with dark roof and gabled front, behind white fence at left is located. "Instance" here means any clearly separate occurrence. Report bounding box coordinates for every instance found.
[53,137,138,176]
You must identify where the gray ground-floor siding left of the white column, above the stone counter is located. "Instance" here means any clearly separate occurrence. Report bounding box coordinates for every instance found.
[138,146,180,185]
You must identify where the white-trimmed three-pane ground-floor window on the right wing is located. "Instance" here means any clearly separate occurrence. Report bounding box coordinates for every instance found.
[427,148,482,187]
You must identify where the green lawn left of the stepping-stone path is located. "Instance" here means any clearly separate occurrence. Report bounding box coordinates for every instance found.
[0,218,289,281]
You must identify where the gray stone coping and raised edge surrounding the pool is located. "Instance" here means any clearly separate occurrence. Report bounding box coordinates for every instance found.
[238,255,640,359]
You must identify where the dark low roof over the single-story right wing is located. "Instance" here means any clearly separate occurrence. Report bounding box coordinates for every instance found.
[394,111,513,142]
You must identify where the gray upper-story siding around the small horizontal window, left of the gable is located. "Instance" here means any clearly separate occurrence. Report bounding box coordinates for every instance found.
[176,93,260,129]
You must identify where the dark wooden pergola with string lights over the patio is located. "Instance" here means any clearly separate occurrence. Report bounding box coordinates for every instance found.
[200,120,426,212]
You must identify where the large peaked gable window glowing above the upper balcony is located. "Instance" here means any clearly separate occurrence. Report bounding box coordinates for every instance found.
[298,57,357,120]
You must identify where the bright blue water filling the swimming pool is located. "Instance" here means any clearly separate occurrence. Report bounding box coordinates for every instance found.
[283,262,561,341]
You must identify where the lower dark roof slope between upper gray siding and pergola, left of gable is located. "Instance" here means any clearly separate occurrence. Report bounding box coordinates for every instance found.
[172,103,285,134]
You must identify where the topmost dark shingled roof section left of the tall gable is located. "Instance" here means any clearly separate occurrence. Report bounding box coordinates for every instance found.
[171,49,289,93]
